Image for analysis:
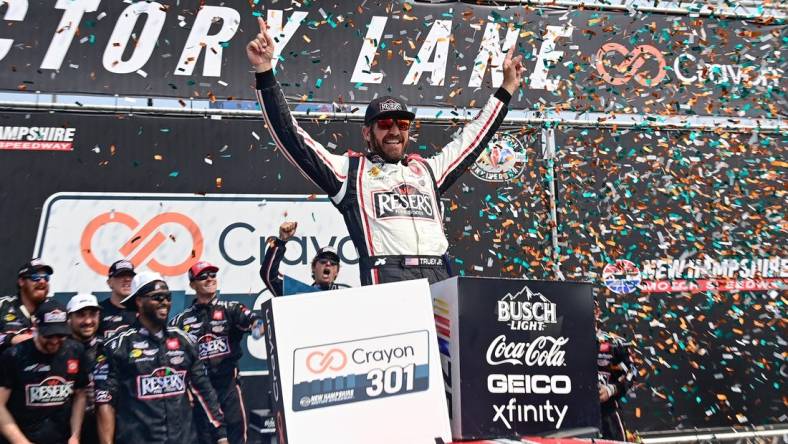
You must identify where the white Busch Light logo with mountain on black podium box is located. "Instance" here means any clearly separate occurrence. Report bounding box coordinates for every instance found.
[497,286,558,331]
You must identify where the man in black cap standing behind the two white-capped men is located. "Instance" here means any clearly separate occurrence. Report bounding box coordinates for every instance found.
[98,259,137,338]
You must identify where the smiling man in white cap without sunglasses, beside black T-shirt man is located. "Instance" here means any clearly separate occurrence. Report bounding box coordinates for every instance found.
[66,293,102,444]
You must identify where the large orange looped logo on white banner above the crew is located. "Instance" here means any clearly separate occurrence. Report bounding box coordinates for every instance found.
[80,211,203,276]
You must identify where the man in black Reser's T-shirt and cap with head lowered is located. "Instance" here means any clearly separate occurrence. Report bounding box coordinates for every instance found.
[0,299,90,444]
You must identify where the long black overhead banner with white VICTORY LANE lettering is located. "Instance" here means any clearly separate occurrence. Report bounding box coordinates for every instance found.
[0,0,786,117]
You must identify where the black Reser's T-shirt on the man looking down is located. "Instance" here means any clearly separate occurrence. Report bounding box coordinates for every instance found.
[0,339,90,444]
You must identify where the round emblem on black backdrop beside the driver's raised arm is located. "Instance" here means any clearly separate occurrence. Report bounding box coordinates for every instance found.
[470,134,526,182]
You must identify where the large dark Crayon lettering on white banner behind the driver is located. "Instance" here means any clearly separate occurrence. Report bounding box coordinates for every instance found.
[219,222,358,266]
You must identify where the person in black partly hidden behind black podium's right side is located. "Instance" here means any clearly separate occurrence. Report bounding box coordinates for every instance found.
[594,301,635,441]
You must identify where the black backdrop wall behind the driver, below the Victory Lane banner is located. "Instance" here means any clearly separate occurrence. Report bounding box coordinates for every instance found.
[0,112,788,431]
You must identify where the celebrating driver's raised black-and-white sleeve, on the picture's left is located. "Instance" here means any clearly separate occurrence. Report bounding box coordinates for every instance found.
[255,70,348,197]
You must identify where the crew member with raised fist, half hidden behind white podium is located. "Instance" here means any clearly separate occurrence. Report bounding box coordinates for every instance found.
[260,222,350,296]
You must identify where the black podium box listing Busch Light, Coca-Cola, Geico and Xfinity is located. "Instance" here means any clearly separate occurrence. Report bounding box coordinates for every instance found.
[430,277,600,439]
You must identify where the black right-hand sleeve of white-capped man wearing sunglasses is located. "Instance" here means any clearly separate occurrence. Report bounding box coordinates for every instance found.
[177,328,227,441]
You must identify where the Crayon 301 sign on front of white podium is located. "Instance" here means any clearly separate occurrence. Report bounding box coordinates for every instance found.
[293,330,430,411]
